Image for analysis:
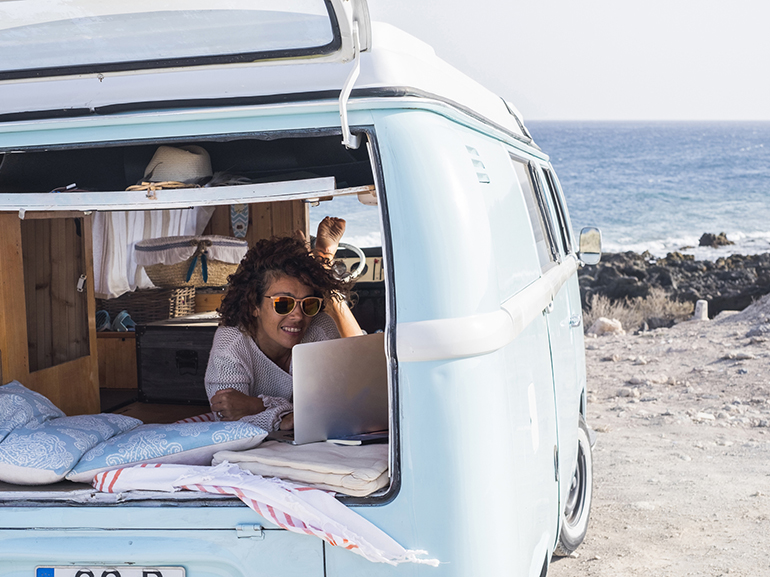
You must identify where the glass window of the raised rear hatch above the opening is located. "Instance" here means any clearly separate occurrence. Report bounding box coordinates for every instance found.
[0,0,338,78]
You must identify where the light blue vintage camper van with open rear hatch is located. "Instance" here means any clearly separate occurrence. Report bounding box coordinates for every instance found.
[0,0,600,577]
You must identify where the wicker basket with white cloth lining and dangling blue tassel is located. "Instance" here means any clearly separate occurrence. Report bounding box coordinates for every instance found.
[137,236,248,288]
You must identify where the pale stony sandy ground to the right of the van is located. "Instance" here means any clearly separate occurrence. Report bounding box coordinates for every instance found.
[548,297,770,577]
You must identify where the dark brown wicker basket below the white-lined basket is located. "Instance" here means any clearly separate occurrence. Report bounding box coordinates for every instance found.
[96,287,195,324]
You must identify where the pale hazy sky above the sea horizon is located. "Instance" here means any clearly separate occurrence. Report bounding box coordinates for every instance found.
[368,0,770,120]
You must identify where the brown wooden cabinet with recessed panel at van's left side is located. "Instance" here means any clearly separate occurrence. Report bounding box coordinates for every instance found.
[0,212,99,415]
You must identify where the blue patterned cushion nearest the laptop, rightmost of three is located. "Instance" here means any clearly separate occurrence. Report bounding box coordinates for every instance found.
[67,421,267,483]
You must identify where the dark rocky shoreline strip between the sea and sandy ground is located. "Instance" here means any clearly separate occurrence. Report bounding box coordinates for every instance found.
[578,252,770,318]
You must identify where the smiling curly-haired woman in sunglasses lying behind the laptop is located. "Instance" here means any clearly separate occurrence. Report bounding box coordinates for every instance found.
[206,218,361,431]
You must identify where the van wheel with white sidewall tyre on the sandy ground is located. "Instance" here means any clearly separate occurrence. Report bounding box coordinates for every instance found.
[553,415,593,557]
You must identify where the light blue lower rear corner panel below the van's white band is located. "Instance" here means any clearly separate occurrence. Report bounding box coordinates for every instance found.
[326,317,558,576]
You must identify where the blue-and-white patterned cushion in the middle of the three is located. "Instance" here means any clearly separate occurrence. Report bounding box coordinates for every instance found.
[0,412,142,485]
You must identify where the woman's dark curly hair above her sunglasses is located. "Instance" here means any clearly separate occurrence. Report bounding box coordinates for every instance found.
[217,237,343,332]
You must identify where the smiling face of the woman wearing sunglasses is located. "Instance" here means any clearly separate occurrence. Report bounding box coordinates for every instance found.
[254,274,315,360]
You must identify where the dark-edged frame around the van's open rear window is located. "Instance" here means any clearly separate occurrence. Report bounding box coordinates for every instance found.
[0,125,401,508]
